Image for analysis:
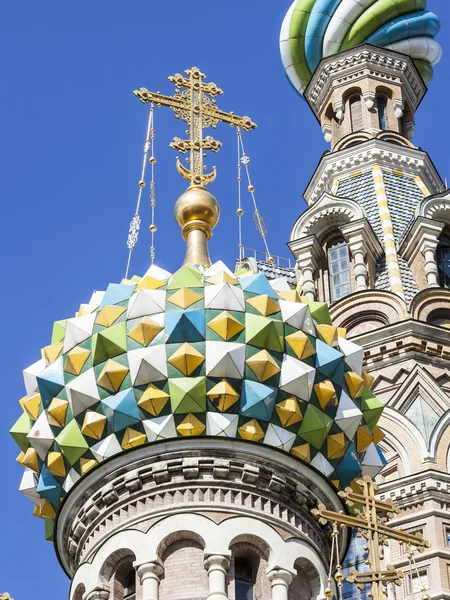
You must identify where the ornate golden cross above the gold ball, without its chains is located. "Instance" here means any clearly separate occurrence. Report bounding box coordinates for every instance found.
[134,67,256,185]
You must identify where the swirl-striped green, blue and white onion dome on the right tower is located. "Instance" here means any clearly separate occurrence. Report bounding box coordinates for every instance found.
[280,0,442,95]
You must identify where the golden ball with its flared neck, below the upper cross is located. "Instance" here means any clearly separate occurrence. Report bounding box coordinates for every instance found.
[174,185,220,265]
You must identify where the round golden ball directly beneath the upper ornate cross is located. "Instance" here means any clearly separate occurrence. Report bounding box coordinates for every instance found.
[174,185,220,237]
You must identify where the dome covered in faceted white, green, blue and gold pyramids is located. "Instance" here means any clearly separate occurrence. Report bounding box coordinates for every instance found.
[11,262,384,540]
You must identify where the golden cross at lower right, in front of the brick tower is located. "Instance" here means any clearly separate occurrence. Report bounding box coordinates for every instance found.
[311,477,431,600]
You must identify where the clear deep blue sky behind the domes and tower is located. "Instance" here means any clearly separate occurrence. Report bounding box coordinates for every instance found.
[0,0,450,600]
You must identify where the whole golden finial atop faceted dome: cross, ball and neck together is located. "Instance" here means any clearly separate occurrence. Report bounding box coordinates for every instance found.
[134,67,256,265]
